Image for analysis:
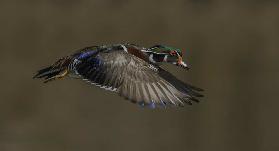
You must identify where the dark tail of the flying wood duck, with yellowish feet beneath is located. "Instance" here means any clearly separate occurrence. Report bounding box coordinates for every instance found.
[33,57,71,83]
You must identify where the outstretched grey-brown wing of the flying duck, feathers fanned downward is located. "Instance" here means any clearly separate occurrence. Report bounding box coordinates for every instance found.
[75,50,201,107]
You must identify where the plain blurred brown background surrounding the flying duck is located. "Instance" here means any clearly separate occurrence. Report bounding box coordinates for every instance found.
[0,0,279,151]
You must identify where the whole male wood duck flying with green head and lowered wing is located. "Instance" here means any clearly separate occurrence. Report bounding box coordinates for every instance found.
[34,44,203,108]
